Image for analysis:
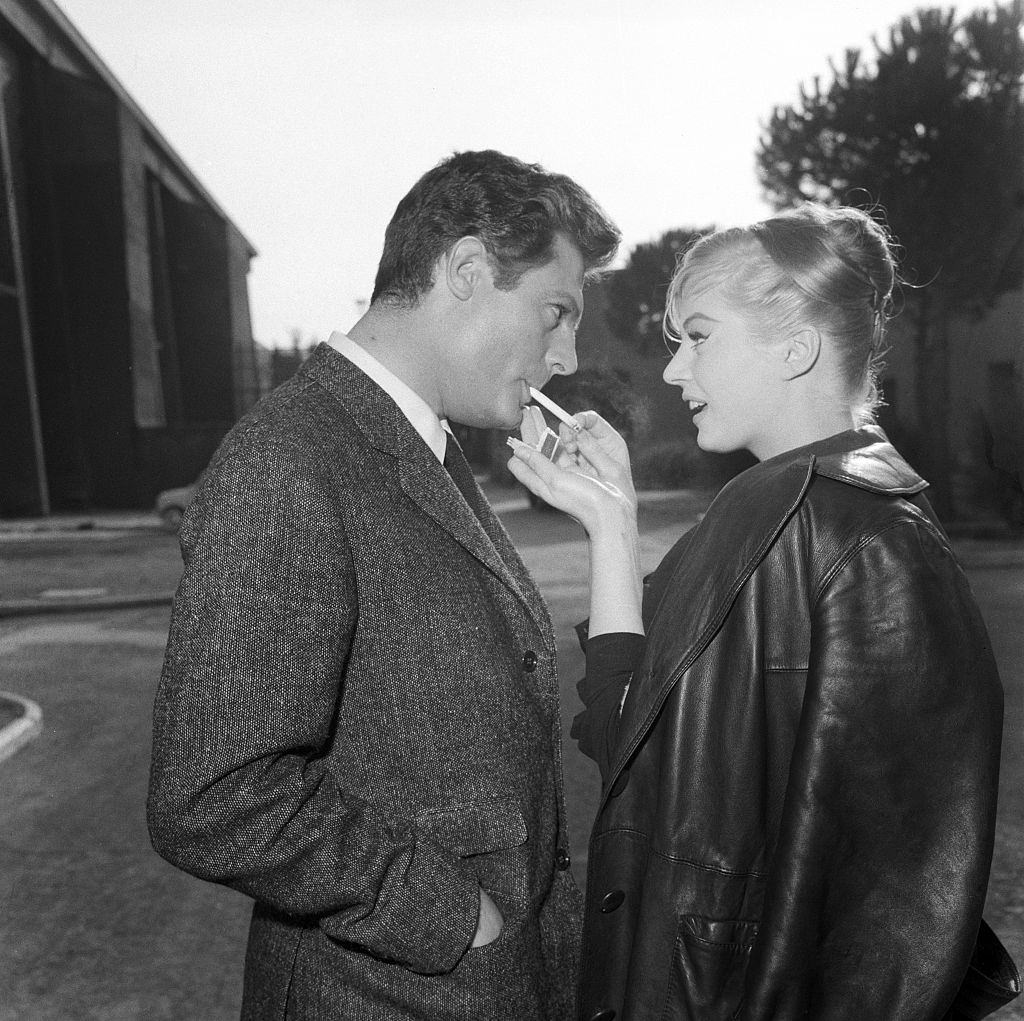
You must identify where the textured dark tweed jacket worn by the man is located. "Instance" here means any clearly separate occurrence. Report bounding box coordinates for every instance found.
[148,345,582,1021]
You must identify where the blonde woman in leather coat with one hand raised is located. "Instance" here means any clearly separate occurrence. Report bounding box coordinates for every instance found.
[510,206,1002,1021]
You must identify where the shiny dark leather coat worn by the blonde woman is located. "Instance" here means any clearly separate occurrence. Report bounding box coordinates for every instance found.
[574,428,1002,1021]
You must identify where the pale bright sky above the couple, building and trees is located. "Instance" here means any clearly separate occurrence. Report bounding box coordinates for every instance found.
[57,0,937,345]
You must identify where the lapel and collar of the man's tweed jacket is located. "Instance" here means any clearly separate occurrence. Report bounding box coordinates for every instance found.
[301,344,550,632]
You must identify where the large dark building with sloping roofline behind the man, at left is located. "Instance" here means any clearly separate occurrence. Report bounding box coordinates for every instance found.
[0,0,258,515]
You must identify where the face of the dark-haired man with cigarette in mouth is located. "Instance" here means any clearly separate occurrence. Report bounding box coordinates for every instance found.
[443,236,584,429]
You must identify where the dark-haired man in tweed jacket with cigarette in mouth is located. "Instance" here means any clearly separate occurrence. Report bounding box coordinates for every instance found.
[148,152,618,1021]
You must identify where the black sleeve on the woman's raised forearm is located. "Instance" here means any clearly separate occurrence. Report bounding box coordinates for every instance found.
[570,631,647,778]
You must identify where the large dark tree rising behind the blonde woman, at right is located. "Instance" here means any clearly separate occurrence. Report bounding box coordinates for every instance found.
[757,0,1024,509]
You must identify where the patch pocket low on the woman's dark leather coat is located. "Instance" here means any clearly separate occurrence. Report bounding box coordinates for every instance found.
[664,914,758,1021]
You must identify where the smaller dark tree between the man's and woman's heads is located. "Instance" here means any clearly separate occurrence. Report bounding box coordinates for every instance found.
[605,227,713,353]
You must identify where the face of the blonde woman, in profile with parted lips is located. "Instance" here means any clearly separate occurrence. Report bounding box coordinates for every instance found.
[664,287,790,461]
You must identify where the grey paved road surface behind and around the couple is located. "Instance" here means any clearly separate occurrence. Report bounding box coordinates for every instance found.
[0,506,1024,1021]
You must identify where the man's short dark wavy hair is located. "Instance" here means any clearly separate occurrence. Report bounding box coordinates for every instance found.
[371,150,621,307]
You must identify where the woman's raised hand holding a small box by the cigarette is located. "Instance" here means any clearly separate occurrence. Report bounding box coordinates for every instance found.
[509,412,637,539]
